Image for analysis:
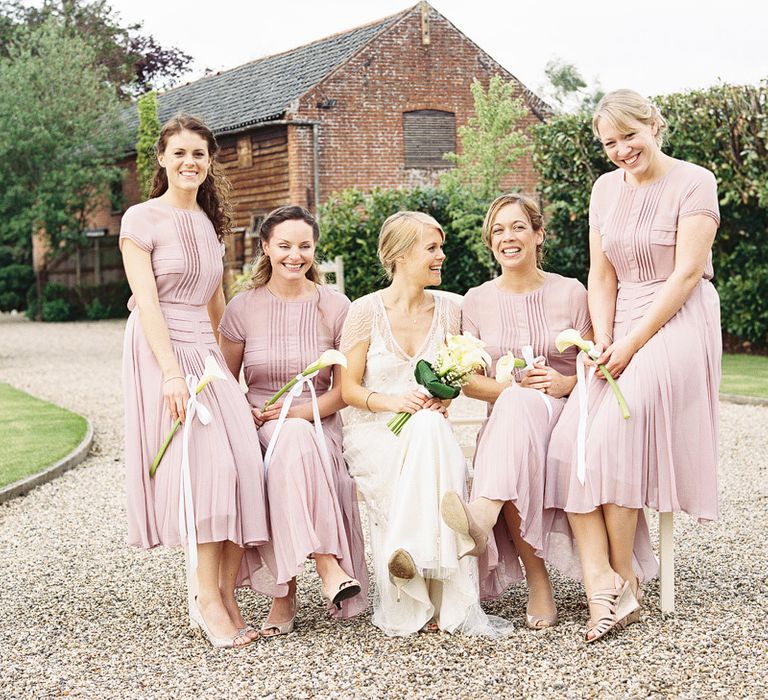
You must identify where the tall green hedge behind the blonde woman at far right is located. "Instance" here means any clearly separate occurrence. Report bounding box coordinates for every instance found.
[533,83,768,346]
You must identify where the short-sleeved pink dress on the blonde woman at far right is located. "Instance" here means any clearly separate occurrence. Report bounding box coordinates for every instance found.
[545,161,722,536]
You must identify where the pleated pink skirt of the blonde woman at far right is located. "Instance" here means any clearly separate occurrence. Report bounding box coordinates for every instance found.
[545,280,722,577]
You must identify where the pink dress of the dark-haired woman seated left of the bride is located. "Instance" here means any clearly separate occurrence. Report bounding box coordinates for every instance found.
[219,286,368,618]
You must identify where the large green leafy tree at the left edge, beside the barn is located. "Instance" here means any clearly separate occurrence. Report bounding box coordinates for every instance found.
[0,18,130,318]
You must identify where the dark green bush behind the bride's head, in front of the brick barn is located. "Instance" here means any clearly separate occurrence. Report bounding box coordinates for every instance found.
[319,187,493,299]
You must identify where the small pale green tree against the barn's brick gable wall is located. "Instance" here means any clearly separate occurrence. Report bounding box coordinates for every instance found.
[440,75,530,201]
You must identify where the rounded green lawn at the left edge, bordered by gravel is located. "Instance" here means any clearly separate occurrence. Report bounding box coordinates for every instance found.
[0,382,87,487]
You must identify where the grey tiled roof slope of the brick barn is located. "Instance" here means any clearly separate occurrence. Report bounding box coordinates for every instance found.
[130,13,404,134]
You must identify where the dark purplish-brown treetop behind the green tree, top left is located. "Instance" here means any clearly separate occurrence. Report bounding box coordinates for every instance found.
[0,0,192,96]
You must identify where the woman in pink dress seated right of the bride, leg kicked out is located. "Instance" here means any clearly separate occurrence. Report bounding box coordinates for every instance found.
[442,194,591,629]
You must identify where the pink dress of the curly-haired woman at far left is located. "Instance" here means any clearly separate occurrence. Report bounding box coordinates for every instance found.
[120,199,270,592]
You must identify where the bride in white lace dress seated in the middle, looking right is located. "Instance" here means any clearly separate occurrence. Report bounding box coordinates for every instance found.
[341,212,508,635]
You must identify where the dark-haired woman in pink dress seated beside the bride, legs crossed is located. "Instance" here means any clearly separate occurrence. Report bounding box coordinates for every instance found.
[219,206,368,636]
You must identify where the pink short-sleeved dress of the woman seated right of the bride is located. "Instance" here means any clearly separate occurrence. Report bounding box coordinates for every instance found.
[461,272,591,600]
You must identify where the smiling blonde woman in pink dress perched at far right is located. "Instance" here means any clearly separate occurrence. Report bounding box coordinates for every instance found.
[545,90,721,642]
